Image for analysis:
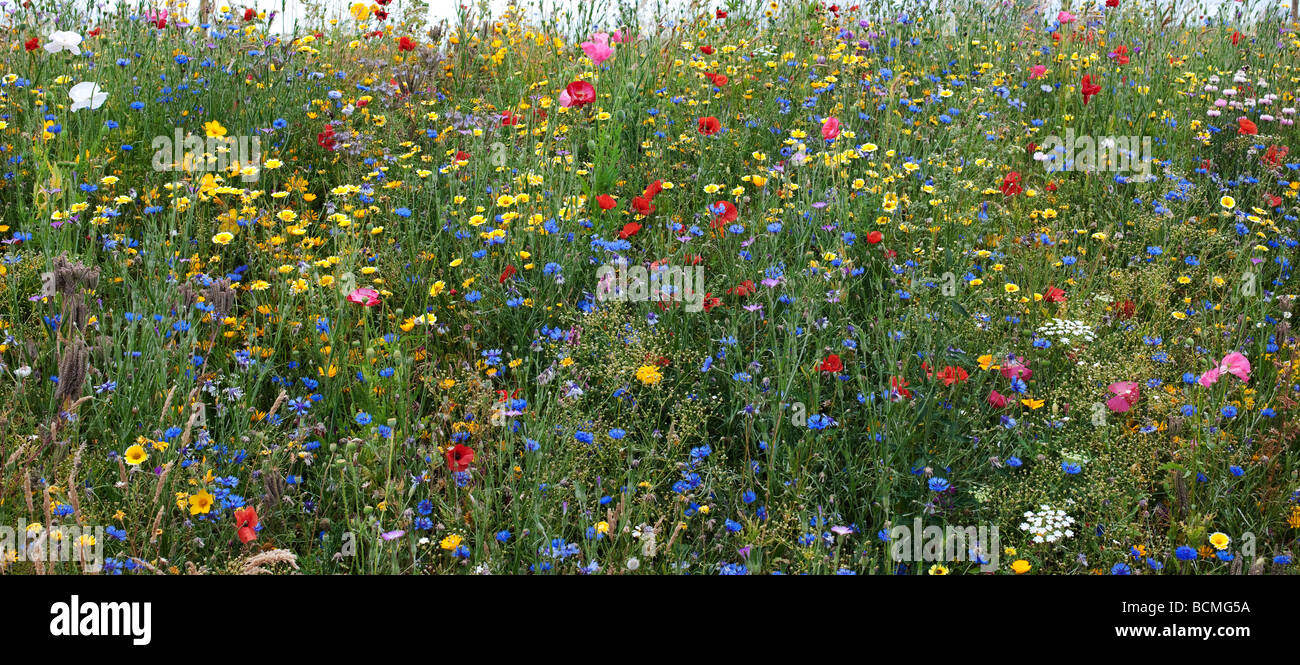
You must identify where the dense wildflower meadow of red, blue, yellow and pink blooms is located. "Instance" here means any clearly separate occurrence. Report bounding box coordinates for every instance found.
[0,0,1300,576]
